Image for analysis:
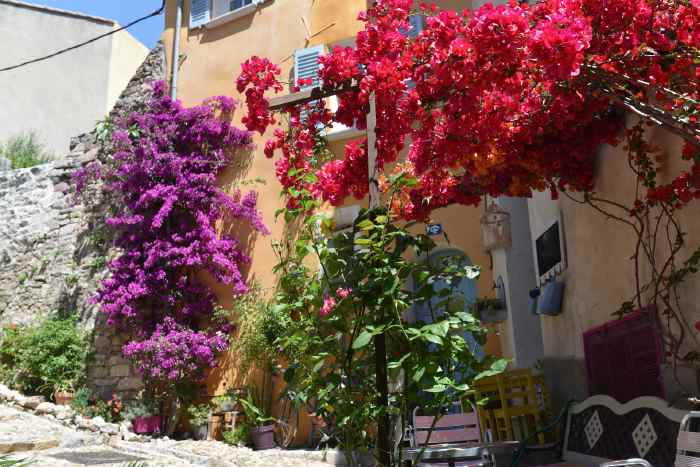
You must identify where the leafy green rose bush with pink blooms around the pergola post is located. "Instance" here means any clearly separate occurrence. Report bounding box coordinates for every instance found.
[276,209,505,458]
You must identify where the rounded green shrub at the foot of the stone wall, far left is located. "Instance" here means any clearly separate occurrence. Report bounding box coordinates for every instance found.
[0,317,88,397]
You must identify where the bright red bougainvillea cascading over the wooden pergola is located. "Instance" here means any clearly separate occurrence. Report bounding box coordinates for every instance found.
[237,0,700,219]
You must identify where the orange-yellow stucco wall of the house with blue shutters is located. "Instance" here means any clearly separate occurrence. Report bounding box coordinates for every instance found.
[163,0,500,439]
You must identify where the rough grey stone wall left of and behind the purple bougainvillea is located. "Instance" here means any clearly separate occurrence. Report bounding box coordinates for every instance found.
[0,44,165,398]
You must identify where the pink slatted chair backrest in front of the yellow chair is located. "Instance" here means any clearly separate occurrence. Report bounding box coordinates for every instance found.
[413,406,482,446]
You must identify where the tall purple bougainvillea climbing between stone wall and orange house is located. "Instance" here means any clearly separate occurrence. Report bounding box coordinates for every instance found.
[76,82,268,392]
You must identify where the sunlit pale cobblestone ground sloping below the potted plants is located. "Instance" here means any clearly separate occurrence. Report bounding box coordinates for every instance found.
[0,404,335,467]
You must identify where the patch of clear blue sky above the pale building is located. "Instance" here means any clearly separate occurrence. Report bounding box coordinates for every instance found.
[23,0,163,48]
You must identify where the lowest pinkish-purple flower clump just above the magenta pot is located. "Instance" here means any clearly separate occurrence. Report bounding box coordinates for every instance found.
[123,318,228,384]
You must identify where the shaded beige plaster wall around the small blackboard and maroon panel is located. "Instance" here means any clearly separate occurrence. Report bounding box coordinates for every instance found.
[529,119,700,410]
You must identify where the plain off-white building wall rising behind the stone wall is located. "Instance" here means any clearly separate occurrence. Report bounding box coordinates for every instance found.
[0,2,145,157]
